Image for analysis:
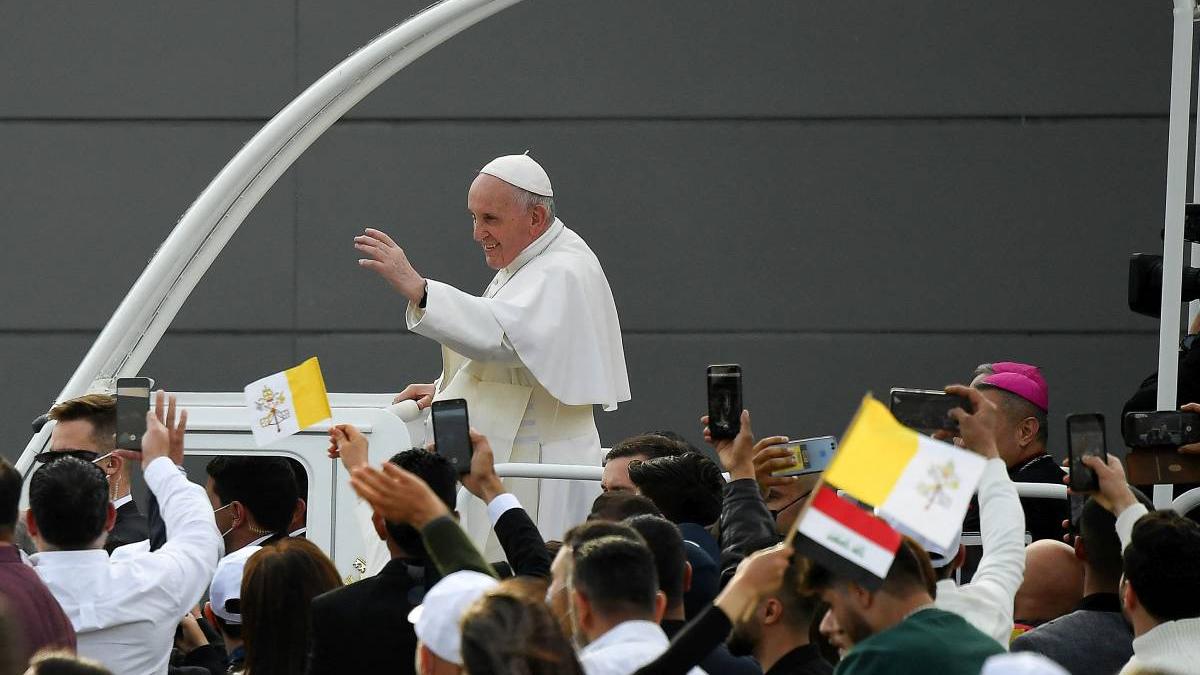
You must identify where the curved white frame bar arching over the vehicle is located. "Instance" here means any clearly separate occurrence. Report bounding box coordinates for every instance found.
[17,0,521,473]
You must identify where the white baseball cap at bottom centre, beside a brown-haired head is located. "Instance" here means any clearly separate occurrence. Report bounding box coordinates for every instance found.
[408,571,499,665]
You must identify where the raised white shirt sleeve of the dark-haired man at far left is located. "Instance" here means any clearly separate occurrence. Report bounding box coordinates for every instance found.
[145,458,222,616]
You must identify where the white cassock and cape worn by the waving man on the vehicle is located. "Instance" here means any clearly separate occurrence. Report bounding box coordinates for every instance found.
[407,219,629,550]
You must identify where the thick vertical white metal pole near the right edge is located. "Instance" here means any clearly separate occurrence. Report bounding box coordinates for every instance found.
[1153,0,1195,508]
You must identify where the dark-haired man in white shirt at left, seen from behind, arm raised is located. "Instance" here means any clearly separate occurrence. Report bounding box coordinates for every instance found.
[26,393,222,675]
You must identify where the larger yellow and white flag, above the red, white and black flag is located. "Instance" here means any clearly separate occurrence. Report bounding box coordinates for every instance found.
[824,395,986,548]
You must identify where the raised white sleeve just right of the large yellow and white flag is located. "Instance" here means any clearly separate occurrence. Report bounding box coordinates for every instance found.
[962,459,1025,623]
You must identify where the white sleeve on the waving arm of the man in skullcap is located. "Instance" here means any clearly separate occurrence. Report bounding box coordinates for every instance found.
[404,279,521,364]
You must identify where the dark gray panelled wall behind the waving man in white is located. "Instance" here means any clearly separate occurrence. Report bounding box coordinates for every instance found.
[0,0,1170,458]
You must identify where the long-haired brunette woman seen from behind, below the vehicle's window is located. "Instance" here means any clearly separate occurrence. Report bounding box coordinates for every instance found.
[240,538,342,675]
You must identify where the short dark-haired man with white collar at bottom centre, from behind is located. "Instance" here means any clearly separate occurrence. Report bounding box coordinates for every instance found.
[570,536,704,675]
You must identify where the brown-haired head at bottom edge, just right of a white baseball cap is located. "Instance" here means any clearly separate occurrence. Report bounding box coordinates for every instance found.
[462,579,583,675]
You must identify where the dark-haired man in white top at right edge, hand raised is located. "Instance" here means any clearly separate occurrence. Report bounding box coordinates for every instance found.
[1084,455,1200,675]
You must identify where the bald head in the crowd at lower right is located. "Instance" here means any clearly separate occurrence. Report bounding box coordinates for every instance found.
[1013,539,1084,623]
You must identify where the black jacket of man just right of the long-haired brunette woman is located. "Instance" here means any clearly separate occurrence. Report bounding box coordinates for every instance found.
[308,560,421,675]
